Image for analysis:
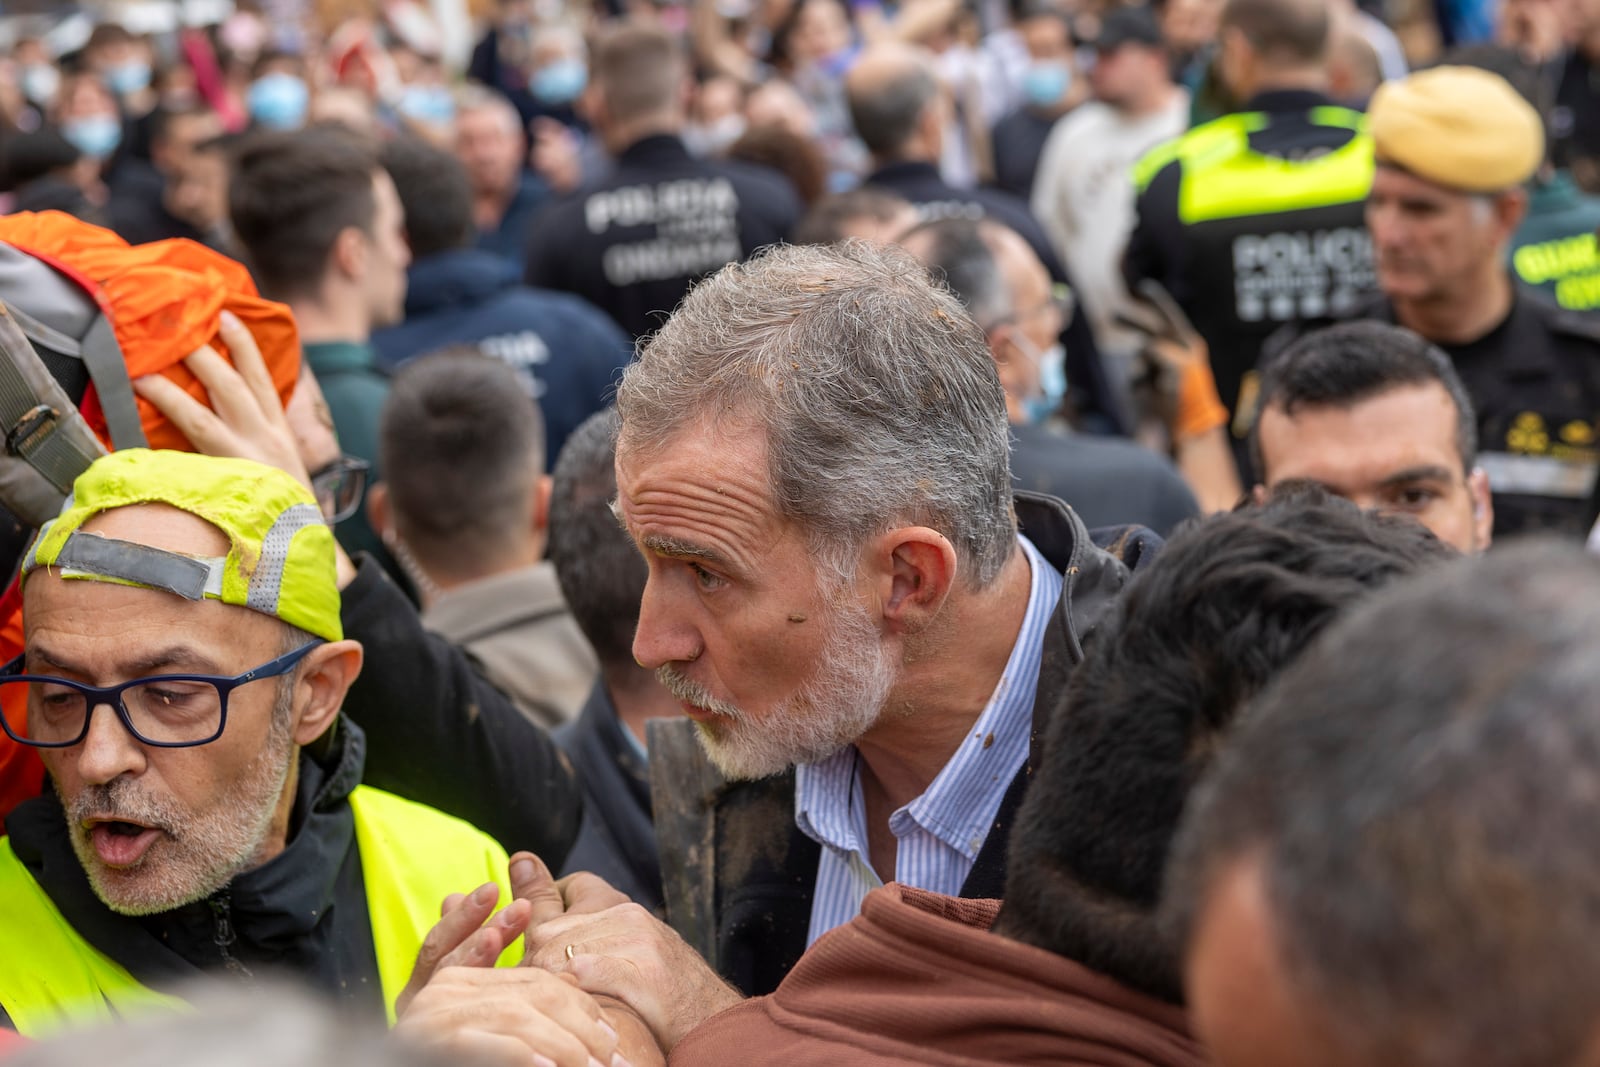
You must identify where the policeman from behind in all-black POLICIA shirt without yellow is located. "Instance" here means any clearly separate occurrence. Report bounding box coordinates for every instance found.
[526,26,800,338]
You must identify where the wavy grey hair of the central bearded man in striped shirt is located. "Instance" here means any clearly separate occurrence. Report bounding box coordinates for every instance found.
[616,240,1016,589]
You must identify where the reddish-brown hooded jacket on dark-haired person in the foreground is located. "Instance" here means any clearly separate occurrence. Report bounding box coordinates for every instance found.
[670,883,1203,1067]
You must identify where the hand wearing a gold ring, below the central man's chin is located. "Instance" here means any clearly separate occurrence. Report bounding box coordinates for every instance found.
[525,875,741,1053]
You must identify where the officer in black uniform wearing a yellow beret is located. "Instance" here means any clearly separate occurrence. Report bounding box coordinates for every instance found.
[1274,67,1600,539]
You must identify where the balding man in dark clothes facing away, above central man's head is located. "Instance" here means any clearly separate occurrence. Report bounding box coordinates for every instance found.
[845,45,1133,434]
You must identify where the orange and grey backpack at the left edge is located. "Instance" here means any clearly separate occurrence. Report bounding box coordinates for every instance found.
[0,211,301,832]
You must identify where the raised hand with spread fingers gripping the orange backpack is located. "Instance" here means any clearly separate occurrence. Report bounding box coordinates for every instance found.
[133,312,310,488]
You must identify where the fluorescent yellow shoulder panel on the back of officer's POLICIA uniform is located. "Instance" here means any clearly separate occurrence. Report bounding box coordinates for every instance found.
[1133,107,1376,224]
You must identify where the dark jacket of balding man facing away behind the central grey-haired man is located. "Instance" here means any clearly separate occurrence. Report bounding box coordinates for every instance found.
[866,160,1133,434]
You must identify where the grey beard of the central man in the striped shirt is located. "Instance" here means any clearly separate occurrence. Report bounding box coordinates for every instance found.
[656,603,899,781]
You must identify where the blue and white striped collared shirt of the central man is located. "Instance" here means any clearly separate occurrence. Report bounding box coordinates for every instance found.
[795,536,1061,945]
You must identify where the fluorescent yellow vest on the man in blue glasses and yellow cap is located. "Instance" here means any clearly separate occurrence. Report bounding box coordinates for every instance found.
[0,785,515,1037]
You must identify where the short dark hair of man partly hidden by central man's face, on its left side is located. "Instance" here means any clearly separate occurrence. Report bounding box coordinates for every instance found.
[550,408,650,669]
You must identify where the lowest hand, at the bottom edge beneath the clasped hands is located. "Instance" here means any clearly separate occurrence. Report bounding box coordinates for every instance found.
[394,966,629,1067]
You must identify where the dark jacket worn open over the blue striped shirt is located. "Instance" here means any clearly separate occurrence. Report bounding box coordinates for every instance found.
[662,493,1162,997]
